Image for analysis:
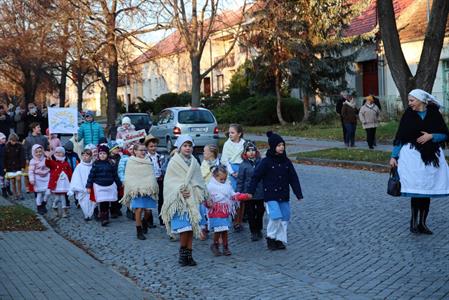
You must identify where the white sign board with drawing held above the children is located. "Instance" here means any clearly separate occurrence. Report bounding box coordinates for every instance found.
[48,107,78,133]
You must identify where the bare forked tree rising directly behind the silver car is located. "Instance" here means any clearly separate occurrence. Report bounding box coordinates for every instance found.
[160,0,247,107]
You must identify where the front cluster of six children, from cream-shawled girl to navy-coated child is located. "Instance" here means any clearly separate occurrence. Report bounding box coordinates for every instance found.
[161,124,303,266]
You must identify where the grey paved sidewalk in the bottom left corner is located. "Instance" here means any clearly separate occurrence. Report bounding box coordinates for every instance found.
[0,197,150,300]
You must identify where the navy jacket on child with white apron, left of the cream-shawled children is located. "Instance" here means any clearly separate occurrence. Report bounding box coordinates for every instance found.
[86,160,122,188]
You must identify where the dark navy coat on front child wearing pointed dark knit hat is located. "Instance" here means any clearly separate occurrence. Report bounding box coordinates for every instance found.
[248,154,303,202]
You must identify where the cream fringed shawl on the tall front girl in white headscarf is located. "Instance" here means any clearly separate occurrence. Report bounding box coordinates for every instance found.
[161,153,208,237]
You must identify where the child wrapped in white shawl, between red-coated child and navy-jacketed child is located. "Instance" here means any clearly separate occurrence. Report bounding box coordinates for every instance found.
[69,149,96,222]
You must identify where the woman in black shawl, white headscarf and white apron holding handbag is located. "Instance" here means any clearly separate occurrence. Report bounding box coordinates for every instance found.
[390,89,449,234]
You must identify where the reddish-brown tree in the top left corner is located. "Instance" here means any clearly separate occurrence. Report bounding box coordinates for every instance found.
[0,0,58,103]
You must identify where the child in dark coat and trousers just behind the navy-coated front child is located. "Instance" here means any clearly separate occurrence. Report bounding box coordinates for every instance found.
[237,141,265,242]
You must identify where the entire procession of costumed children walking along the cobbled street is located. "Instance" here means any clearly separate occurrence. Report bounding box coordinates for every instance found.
[0,124,302,266]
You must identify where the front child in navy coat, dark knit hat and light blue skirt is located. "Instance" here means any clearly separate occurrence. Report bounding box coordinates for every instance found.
[248,131,303,250]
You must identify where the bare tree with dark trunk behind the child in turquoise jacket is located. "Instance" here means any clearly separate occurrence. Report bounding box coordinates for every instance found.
[71,0,164,128]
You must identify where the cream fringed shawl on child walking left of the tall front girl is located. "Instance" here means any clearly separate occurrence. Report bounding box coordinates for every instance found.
[120,156,159,206]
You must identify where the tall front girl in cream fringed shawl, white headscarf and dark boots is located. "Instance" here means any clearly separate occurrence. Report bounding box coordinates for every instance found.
[161,134,208,266]
